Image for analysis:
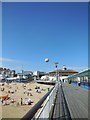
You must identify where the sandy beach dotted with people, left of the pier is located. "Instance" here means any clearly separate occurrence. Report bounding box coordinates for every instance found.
[0,82,52,119]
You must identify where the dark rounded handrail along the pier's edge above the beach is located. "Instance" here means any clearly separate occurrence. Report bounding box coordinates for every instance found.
[21,87,54,120]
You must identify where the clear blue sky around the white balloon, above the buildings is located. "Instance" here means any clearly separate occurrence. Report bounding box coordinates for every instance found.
[2,2,88,71]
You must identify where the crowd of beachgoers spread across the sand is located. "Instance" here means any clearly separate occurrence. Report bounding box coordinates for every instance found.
[0,83,50,106]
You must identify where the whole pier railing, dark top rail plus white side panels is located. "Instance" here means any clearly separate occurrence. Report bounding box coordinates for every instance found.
[21,84,58,120]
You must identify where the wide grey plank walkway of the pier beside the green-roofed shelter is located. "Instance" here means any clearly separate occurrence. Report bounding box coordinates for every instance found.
[62,83,90,119]
